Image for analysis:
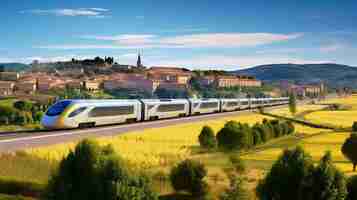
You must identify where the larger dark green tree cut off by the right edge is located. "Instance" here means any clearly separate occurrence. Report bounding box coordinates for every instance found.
[341,133,357,171]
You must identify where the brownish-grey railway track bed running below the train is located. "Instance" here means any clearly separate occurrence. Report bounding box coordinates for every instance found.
[0,105,286,152]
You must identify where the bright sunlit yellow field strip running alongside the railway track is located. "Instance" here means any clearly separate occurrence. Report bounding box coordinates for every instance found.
[27,114,267,168]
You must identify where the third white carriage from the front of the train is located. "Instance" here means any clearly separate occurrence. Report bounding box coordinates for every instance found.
[189,99,221,115]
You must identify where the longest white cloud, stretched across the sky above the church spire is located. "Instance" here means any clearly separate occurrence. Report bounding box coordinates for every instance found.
[76,33,302,48]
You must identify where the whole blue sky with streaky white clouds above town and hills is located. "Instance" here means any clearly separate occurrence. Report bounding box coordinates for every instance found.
[0,0,357,70]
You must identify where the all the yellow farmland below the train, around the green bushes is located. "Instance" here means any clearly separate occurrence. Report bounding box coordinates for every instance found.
[0,97,357,198]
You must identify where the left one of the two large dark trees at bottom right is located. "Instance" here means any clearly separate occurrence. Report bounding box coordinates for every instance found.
[256,147,314,200]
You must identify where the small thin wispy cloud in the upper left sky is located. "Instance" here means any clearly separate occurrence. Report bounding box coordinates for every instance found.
[21,8,110,17]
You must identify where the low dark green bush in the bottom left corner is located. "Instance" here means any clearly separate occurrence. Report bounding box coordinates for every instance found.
[0,179,45,197]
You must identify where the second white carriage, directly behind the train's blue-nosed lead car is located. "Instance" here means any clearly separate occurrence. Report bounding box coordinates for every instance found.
[140,99,190,120]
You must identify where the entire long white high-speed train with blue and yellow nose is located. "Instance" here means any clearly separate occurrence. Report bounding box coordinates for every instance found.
[42,97,289,129]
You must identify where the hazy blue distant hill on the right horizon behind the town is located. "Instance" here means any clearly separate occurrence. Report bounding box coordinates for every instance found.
[233,64,357,88]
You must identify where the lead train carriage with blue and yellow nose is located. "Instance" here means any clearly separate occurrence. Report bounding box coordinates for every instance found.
[42,100,141,129]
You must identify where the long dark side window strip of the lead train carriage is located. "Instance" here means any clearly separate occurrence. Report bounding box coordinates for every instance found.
[89,106,134,117]
